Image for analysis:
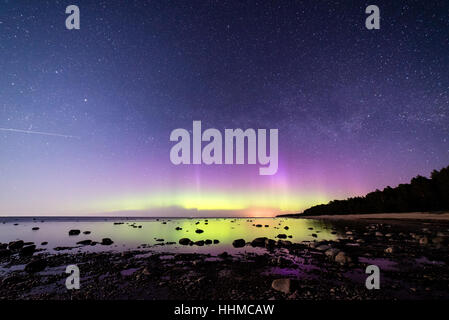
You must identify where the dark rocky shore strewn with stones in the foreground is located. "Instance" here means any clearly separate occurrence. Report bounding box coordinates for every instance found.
[0,219,449,300]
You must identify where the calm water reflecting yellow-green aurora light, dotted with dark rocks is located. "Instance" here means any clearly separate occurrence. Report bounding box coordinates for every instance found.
[0,218,337,254]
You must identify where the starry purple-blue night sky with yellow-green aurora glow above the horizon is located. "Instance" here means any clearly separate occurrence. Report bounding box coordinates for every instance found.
[0,0,449,216]
